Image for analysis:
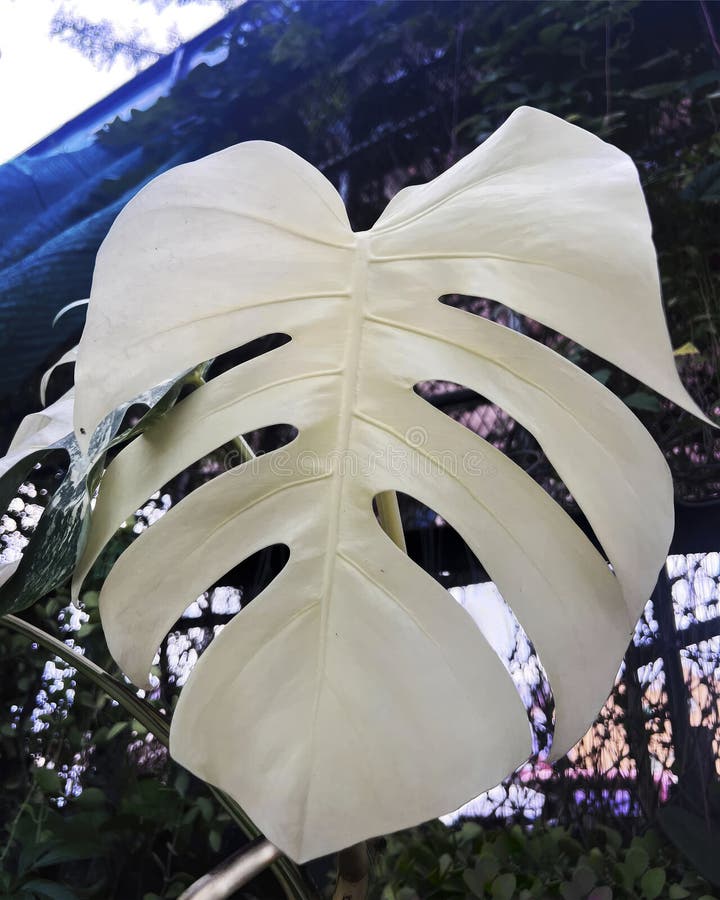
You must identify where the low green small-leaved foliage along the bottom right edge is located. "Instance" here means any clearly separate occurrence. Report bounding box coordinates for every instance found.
[370,821,712,900]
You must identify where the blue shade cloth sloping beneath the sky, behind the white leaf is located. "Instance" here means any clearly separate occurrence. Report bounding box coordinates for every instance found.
[0,11,242,414]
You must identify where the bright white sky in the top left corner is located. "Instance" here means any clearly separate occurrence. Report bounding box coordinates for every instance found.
[0,0,233,163]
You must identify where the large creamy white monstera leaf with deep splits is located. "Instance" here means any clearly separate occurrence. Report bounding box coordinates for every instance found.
[75,108,699,861]
